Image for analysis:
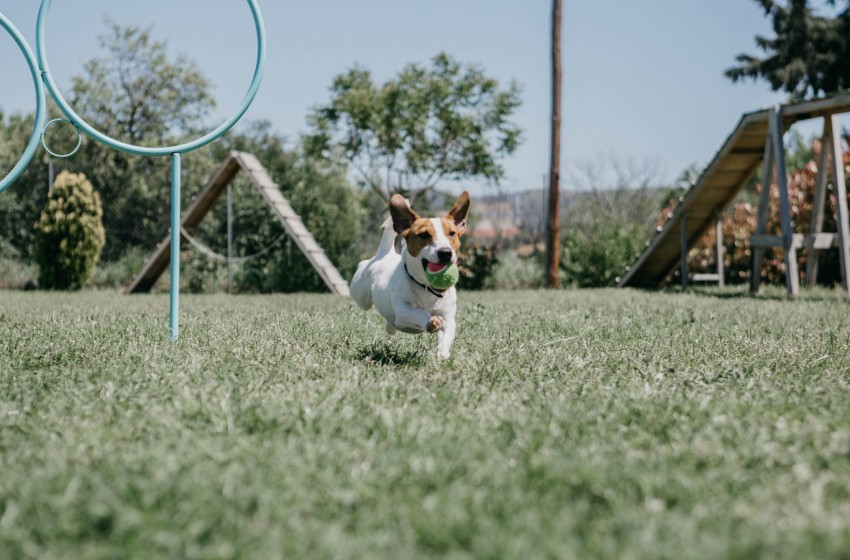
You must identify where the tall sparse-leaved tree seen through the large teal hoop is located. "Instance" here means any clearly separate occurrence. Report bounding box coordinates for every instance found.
[68,21,215,260]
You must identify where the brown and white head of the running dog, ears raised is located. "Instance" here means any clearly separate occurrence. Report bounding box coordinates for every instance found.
[390,191,469,270]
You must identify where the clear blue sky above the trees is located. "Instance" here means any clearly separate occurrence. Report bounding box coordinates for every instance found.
[0,0,836,194]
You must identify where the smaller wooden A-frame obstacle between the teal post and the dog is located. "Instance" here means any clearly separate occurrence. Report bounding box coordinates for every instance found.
[126,151,348,296]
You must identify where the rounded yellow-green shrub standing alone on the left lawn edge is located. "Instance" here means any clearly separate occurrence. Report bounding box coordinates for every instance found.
[35,171,106,290]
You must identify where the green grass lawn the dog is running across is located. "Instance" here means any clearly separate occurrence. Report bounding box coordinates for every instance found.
[0,290,850,560]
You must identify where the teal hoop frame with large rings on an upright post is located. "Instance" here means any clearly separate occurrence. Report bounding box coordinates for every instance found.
[0,0,266,341]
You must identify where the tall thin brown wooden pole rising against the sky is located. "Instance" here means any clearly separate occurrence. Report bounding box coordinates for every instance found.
[546,0,561,289]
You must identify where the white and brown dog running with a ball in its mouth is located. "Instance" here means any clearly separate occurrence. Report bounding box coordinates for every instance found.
[351,191,469,359]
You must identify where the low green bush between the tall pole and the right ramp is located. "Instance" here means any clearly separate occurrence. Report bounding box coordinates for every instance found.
[561,220,645,288]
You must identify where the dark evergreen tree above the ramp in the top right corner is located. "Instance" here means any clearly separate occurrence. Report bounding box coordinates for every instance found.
[725,0,850,100]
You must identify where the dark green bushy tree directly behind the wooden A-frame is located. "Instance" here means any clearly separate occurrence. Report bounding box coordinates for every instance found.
[185,121,362,292]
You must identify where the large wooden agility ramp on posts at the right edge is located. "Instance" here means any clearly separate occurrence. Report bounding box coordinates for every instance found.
[617,93,850,295]
